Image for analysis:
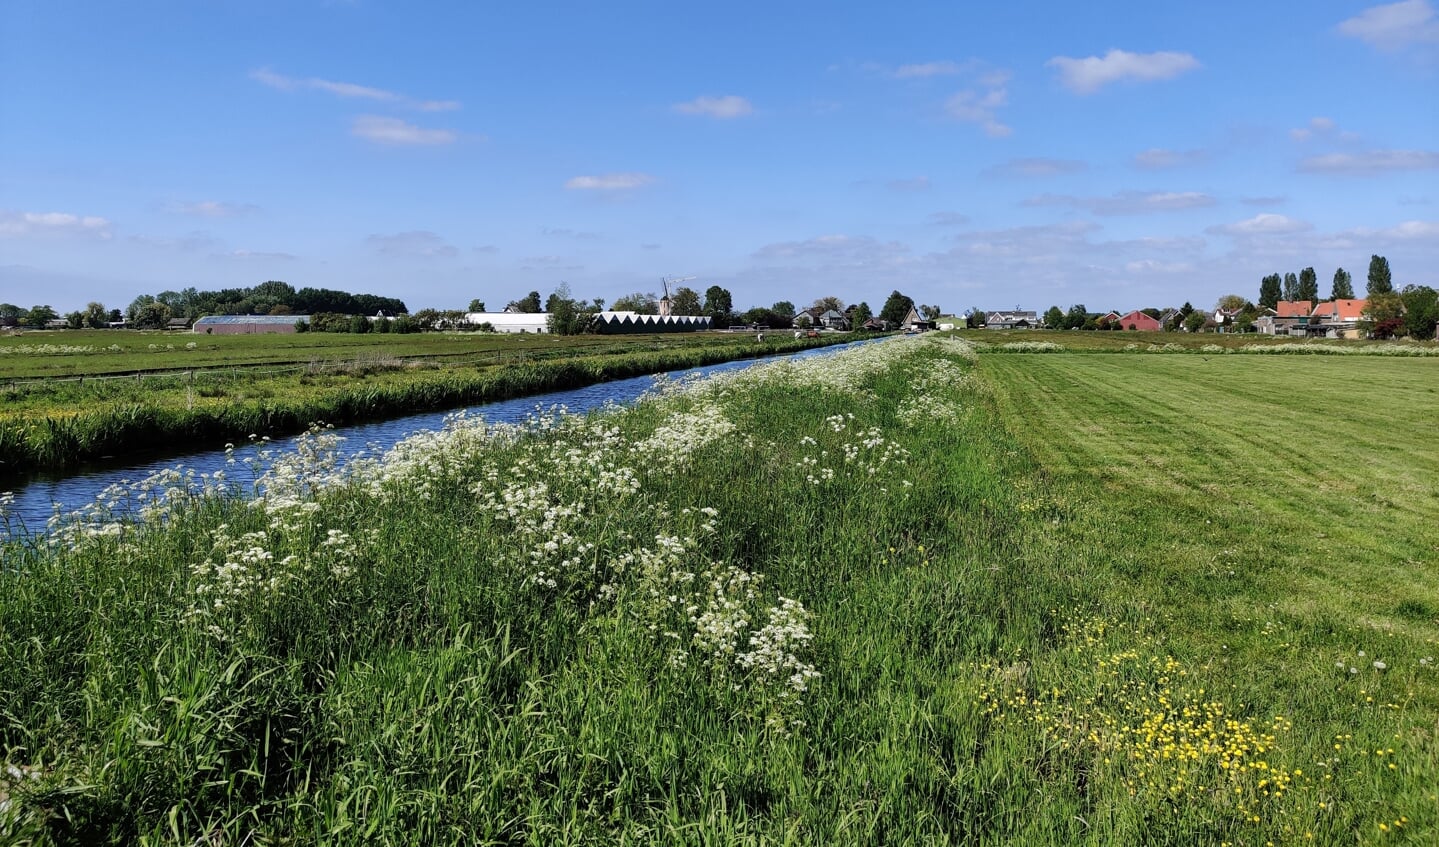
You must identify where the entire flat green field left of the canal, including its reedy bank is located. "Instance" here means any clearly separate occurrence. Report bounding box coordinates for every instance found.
[0,331,852,476]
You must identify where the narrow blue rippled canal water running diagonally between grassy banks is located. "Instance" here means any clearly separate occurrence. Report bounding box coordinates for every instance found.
[0,333,882,535]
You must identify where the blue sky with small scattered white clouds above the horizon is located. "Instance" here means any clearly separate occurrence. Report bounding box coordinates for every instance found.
[0,0,1439,312]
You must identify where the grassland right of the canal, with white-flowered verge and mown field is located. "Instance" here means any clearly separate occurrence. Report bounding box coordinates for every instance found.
[0,336,1439,844]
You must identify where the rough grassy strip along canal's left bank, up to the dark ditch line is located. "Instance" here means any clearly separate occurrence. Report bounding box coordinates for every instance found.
[0,335,850,476]
